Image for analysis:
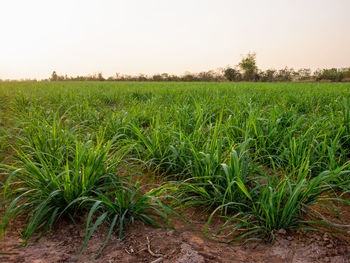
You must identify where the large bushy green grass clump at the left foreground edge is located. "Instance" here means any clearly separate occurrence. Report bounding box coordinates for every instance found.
[0,133,120,242]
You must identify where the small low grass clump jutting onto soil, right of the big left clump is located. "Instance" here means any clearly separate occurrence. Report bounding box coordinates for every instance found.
[81,182,179,256]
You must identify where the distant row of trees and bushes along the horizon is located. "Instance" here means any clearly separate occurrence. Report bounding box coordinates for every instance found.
[0,53,350,82]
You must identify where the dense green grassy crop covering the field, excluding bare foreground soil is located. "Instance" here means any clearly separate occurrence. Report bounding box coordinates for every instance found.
[0,82,350,256]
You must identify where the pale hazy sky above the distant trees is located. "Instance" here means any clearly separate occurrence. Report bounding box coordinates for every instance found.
[0,0,350,79]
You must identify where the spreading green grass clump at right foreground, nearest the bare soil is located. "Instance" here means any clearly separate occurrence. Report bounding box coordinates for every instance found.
[207,165,350,241]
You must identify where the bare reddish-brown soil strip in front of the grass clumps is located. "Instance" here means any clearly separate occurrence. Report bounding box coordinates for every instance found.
[0,207,350,263]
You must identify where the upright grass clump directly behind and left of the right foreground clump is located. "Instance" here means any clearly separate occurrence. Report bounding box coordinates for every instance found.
[170,140,254,213]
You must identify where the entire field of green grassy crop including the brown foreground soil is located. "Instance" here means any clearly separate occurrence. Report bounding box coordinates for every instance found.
[0,82,350,262]
